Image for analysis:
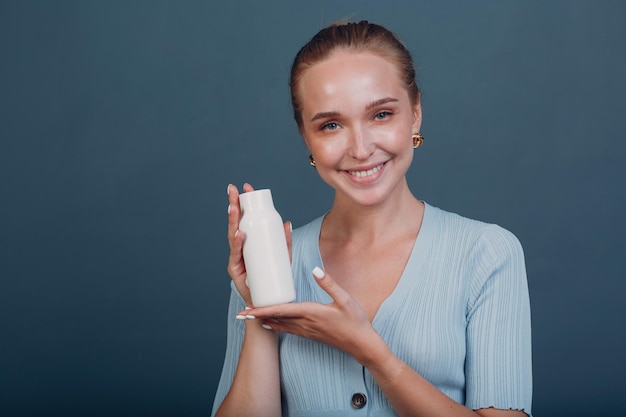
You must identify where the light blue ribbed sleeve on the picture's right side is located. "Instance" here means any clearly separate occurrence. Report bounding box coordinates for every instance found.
[465,225,532,416]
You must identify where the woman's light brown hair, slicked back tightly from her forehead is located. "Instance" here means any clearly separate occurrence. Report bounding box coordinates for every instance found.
[289,20,419,129]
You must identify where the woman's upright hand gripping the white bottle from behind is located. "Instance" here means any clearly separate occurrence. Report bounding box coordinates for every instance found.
[227,183,291,306]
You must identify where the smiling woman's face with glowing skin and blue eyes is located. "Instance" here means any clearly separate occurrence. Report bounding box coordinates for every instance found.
[298,51,421,206]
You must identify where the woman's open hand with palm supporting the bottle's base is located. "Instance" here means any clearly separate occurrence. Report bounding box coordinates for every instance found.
[239,268,386,363]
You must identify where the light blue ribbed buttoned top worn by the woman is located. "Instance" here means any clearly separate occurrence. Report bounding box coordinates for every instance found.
[213,204,532,417]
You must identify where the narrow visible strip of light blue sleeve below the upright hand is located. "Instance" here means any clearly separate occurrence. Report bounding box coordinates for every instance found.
[211,282,246,416]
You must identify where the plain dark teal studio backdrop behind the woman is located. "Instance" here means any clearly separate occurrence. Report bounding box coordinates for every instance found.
[0,0,626,417]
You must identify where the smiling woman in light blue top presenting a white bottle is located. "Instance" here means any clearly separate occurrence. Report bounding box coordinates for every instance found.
[214,22,531,417]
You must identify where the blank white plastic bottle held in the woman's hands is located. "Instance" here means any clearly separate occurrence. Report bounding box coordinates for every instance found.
[239,189,296,307]
